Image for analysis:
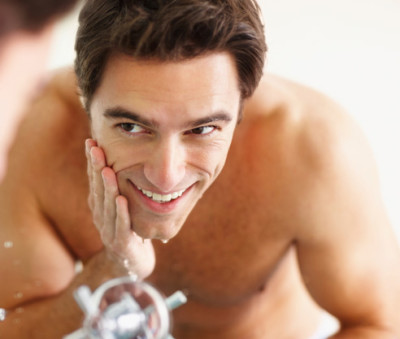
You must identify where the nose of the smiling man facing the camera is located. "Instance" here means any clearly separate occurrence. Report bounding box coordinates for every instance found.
[144,138,186,193]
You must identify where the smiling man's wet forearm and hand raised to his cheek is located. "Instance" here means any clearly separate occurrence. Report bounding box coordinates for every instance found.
[0,141,154,338]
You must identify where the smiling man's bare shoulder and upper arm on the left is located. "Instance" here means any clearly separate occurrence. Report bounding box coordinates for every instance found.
[0,71,88,308]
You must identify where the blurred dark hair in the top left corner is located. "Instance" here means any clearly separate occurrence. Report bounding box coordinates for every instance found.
[0,0,77,38]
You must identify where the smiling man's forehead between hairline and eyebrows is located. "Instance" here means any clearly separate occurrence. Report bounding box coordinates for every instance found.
[91,53,240,121]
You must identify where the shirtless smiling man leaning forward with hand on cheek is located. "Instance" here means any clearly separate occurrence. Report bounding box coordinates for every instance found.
[0,0,400,339]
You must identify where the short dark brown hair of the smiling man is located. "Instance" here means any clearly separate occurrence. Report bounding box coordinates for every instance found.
[75,0,267,112]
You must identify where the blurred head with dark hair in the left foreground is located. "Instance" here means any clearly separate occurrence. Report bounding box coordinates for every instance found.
[0,0,76,181]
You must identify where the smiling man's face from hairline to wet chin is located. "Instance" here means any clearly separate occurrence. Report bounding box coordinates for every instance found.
[91,54,240,239]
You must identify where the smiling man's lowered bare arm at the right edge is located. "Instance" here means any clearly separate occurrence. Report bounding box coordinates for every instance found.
[297,105,400,339]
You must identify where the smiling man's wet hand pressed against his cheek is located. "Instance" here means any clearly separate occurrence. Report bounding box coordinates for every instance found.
[86,139,155,278]
